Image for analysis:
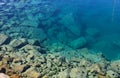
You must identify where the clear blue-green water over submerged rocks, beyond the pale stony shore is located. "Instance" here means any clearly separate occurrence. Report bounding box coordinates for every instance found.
[0,0,120,59]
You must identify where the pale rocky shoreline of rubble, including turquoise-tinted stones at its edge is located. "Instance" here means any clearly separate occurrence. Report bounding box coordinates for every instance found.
[0,34,120,78]
